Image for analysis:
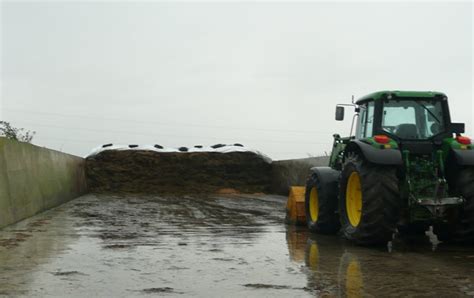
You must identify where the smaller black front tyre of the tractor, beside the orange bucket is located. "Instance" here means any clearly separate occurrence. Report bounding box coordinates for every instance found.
[305,168,340,234]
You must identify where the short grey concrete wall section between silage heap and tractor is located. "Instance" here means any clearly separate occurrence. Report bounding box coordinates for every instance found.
[272,156,329,195]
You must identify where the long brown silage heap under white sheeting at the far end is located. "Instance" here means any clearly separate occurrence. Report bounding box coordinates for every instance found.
[86,146,272,193]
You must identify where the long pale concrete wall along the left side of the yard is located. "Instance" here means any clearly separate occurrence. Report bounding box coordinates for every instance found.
[0,137,87,228]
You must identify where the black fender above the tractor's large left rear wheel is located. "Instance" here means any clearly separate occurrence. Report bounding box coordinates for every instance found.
[344,140,403,166]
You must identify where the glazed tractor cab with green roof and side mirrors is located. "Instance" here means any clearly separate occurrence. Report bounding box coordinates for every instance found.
[336,91,464,148]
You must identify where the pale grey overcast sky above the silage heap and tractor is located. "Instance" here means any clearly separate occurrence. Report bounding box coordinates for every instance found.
[0,1,473,159]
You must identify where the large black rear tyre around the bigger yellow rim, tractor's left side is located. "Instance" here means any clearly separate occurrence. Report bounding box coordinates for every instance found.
[339,155,401,245]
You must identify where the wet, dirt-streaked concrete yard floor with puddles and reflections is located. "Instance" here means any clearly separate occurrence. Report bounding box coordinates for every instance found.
[0,195,474,297]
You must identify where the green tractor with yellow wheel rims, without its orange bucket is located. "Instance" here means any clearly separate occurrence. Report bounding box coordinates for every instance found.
[305,91,474,245]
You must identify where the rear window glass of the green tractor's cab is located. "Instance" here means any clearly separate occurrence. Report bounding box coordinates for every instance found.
[382,99,444,140]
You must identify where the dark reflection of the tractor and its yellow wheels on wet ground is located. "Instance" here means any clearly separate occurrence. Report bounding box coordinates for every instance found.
[286,226,474,297]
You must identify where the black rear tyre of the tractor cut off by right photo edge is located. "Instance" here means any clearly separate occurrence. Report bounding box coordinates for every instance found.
[452,168,474,244]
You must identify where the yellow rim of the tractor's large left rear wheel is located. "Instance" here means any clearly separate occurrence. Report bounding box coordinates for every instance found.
[346,172,362,227]
